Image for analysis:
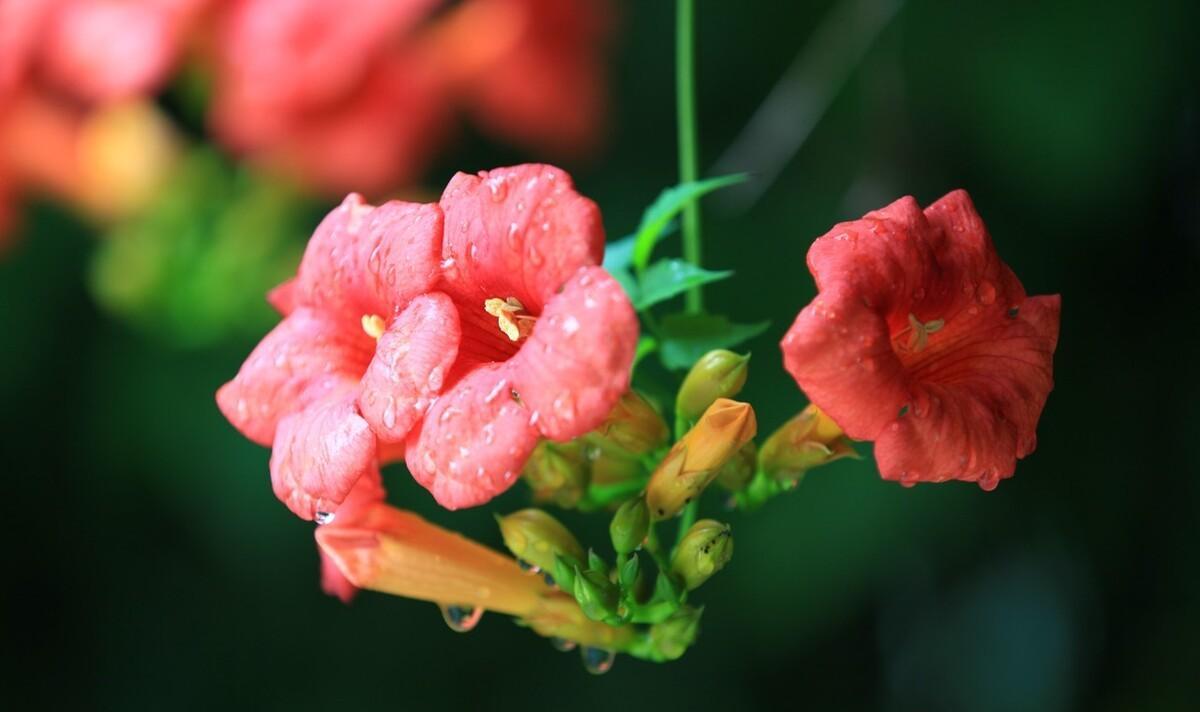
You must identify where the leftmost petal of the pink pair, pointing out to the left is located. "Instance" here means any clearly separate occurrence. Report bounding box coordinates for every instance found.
[217,307,374,445]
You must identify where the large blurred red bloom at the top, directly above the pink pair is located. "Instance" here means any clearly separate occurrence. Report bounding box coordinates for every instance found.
[210,0,608,193]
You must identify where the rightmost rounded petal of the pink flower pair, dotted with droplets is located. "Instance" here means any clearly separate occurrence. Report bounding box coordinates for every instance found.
[509,267,637,441]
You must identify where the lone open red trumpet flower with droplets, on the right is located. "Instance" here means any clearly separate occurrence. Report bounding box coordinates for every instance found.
[781,191,1061,490]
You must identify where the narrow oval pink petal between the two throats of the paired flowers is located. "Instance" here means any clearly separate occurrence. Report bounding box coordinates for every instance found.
[359,293,462,442]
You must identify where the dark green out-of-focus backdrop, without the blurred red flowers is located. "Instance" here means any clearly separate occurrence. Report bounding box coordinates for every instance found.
[0,0,1200,711]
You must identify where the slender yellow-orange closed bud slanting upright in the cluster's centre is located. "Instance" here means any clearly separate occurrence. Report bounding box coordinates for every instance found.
[646,399,757,520]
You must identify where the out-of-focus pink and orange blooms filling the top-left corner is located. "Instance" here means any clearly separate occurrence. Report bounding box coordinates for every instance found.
[0,0,205,238]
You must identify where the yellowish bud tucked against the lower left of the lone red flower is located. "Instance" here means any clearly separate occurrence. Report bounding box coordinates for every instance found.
[758,405,858,483]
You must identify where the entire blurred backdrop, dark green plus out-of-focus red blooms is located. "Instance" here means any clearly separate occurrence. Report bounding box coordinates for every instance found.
[0,0,1200,711]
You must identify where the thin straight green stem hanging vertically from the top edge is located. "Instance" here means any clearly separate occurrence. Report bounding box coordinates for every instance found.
[676,0,704,313]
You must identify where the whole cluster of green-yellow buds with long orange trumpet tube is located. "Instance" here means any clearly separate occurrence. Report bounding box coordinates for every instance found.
[318,351,854,672]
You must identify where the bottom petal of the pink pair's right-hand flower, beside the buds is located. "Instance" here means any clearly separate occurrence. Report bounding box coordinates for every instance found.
[407,364,538,509]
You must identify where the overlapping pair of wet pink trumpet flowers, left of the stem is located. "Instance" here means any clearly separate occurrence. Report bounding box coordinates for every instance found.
[217,164,637,520]
